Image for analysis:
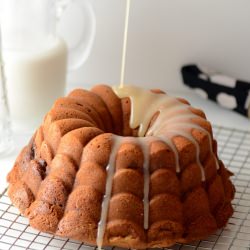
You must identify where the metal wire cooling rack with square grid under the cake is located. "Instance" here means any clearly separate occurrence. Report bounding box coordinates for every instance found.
[0,126,250,250]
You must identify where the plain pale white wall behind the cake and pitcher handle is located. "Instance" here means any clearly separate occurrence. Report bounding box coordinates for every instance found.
[69,0,250,91]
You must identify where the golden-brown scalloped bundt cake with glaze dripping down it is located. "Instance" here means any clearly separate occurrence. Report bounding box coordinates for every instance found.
[8,85,235,249]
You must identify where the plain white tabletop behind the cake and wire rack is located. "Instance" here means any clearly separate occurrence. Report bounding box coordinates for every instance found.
[0,91,250,192]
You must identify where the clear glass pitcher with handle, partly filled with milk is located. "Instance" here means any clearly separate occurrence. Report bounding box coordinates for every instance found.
[0,0,95,132]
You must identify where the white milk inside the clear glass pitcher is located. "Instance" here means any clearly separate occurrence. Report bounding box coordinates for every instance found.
[3,38,67,132]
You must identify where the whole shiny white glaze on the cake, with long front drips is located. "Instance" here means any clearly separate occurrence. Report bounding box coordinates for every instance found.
[97,85,219,249]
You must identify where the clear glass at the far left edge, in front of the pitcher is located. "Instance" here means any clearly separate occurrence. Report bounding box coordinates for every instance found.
[0,25,12,157]
